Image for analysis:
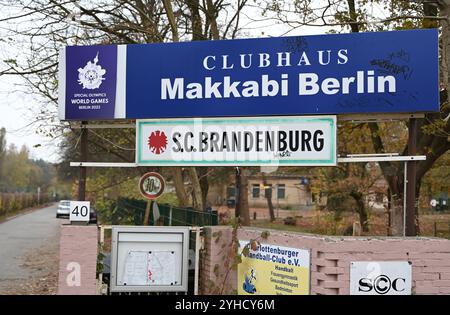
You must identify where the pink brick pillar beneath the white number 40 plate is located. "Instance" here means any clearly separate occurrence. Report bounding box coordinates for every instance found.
[57,225,98,295]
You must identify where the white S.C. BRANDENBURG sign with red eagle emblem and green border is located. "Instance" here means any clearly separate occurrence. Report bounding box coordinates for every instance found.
[136,116,337,166]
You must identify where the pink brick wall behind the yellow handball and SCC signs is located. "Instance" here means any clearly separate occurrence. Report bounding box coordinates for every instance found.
[200,226,450,295]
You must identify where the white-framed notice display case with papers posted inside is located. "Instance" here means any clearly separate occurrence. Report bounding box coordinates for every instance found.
[110,226,189,292]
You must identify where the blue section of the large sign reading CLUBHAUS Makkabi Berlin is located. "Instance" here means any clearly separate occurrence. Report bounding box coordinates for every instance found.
[60,29,439,119]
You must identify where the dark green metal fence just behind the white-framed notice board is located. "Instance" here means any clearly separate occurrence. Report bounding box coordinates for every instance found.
[111,198,219,226]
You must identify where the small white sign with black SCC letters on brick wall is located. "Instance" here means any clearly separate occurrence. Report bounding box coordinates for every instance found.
[350,261,412,295]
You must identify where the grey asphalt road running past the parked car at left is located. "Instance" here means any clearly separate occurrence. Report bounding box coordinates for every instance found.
[0,203,63,294]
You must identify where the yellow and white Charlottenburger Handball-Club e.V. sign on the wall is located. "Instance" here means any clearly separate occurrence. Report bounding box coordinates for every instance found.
[237,240,310,295]
